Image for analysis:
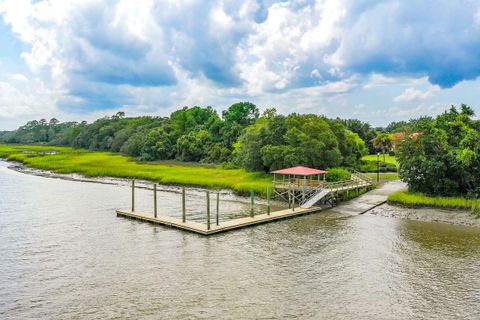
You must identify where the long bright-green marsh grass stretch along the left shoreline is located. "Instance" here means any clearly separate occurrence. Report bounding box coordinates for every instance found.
[0,145,272,194]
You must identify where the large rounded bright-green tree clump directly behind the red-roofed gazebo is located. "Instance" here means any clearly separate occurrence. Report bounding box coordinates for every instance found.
[234,110,366,171]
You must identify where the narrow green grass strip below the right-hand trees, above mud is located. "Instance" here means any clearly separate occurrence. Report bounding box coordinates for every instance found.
[388,191,480,210]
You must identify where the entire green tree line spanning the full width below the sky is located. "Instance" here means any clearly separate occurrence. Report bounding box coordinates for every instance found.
[0,102,480,198]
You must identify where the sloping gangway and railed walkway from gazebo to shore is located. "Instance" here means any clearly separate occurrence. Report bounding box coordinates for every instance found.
[300,171,372,209]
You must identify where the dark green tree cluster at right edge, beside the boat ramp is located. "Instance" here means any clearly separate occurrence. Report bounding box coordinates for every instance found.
[397,105,480,198]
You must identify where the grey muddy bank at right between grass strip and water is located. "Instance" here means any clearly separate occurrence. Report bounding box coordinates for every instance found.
[366,203,480,227]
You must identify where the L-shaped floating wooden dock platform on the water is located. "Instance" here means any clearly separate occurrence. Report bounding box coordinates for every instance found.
[117,207,322,236]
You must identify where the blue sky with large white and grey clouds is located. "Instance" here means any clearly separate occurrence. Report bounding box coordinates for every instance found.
[0,0,480,130]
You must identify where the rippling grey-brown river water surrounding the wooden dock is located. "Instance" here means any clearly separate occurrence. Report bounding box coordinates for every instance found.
[0,162,480,319]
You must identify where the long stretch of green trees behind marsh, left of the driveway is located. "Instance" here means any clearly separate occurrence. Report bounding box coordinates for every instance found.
[0,102,370,171]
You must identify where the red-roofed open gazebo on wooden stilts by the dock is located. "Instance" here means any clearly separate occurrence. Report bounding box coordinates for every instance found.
[271,166,327,203]
